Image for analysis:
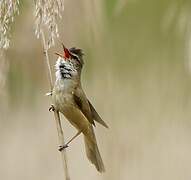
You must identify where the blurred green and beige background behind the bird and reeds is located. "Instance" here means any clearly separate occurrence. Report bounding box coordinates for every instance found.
[0,0,191,180]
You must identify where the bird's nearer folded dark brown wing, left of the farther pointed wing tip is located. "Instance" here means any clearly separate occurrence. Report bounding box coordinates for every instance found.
[73,88,95,126]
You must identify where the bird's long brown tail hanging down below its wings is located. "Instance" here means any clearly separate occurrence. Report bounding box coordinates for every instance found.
[84,127,105,173]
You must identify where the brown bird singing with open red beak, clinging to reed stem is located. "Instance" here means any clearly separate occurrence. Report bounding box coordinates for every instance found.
[52,44,108,173]
